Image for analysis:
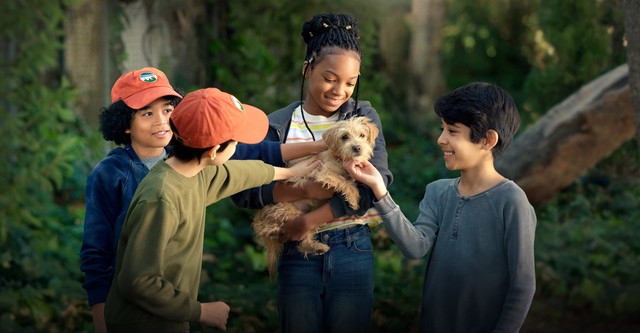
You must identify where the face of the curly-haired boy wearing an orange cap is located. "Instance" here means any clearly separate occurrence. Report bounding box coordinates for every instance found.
[126,97,173,158]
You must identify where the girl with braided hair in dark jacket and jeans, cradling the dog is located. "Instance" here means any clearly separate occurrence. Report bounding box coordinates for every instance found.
[233,14,393,333]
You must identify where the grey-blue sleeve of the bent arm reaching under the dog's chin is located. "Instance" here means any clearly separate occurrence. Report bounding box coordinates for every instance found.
[375,186,439,259]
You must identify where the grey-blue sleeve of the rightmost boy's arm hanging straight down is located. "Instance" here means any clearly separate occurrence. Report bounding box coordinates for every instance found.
[496,190,537,332]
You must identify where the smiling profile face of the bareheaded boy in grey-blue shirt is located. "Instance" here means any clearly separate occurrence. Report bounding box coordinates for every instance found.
[438,120,491,171]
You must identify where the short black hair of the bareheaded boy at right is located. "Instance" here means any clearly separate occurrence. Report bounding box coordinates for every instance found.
[434,82,520,158]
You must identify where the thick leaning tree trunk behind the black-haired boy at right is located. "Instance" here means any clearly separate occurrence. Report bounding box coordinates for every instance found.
[496,64,635,204]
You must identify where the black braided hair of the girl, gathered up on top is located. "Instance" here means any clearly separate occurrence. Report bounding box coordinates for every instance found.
[300,14,362,111]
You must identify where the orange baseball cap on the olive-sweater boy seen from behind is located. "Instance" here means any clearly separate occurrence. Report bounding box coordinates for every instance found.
[171,88,269,148]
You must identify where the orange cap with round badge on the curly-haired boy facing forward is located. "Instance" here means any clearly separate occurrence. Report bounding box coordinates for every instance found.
[111,67,182,110]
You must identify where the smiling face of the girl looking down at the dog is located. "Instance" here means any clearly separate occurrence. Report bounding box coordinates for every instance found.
[303,50,360,117]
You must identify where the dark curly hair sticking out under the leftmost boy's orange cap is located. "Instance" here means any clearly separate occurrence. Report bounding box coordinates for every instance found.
[99,89,182,145]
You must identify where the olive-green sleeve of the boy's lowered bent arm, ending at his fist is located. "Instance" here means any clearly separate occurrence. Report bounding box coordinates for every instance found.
[115,200,200,322]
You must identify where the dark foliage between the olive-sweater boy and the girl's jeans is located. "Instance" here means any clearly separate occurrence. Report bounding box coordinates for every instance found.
[198,199,279,333]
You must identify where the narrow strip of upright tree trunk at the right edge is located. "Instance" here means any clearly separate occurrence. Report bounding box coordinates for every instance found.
[622,0,640,150]
